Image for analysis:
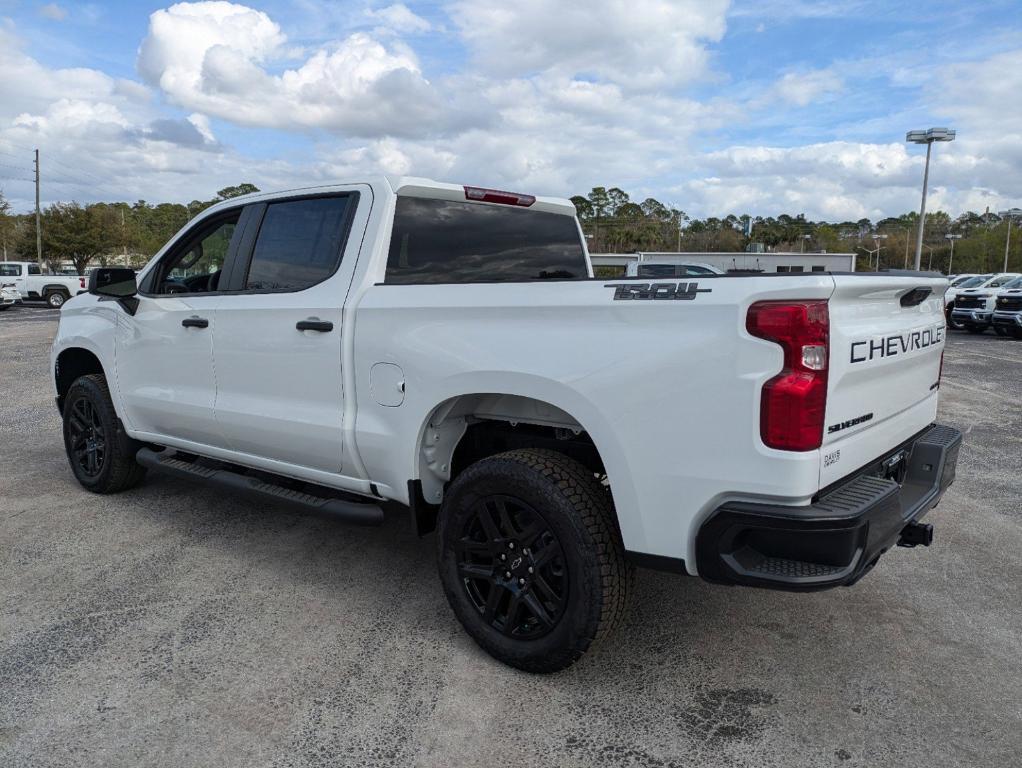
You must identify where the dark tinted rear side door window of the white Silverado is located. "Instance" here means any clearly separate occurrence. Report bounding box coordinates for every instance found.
[244,194,357,291]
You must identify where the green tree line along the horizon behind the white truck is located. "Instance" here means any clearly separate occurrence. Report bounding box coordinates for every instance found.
[0,183,1022,273]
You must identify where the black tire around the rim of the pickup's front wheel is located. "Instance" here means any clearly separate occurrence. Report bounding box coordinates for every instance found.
[63,373,145,494]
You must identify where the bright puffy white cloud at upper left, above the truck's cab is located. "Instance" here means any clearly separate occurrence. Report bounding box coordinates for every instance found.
[138,2,457,136]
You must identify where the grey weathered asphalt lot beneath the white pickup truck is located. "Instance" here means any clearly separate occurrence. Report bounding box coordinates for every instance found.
[0,307,1022,768]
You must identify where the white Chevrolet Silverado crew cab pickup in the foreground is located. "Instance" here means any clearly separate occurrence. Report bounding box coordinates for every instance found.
[52,177,961,672]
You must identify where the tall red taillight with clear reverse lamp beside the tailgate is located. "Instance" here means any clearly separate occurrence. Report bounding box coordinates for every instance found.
[745,301,830,451]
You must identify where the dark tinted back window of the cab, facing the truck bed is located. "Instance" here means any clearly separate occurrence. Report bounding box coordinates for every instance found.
[386,197,589,284]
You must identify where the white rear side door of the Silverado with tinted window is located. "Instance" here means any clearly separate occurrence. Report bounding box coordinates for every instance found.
[214,185,371,472]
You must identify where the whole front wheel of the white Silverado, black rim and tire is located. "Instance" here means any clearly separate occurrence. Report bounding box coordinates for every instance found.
[63,374,145,493]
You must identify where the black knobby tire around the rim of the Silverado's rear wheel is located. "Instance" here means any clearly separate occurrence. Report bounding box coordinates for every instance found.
[437,450,635,673]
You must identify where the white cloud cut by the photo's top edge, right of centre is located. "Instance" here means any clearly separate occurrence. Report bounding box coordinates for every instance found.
[448,0,728,89]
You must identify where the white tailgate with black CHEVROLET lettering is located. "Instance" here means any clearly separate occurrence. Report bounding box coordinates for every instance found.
[820,274,947,487]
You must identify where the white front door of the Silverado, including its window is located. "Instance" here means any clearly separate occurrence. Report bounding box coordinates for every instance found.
[115,209,240,448]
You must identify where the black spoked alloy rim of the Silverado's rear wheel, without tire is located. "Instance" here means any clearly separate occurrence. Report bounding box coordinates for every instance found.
[456,495,570,640]
